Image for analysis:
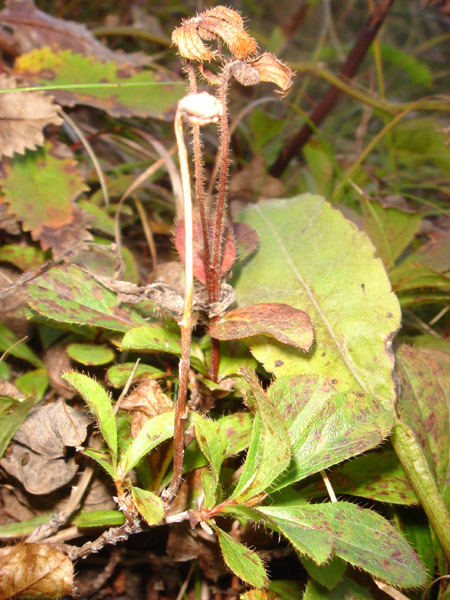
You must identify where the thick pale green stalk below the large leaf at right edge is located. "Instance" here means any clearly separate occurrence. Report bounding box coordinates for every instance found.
[391,420,450,561]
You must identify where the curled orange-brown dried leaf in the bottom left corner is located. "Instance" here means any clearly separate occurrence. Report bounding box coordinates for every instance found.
[0,544,73,600]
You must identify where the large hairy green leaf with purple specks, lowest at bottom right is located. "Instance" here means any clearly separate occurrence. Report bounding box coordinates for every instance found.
[254,502,426,588]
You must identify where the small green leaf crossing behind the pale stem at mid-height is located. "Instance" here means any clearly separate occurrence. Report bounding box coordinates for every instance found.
[122,325,204,366]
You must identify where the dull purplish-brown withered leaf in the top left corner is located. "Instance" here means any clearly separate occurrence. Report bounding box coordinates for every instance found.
[0,0,150,67]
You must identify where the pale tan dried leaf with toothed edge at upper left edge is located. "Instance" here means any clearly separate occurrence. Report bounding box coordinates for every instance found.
[0,75,62,157]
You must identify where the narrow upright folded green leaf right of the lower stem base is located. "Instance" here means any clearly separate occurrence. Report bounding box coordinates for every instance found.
[231,369,291,503]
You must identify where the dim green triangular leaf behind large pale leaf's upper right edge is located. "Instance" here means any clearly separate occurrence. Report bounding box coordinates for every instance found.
[361,201,422,269]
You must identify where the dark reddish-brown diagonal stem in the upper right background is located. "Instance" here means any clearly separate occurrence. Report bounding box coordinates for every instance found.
[269,0,394,177]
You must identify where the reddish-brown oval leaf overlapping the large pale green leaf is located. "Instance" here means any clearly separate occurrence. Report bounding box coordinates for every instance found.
[210,303,314,352]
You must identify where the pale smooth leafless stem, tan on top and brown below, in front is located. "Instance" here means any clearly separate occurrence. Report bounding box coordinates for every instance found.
[163,109,194,504]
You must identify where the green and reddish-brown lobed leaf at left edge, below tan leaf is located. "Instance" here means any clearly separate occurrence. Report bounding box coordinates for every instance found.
[0,141,90,255]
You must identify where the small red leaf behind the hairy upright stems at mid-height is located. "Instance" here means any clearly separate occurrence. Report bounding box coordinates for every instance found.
[175,212,236,285]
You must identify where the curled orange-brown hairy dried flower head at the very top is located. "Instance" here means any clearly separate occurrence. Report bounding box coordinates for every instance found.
[172,6,257,62]
